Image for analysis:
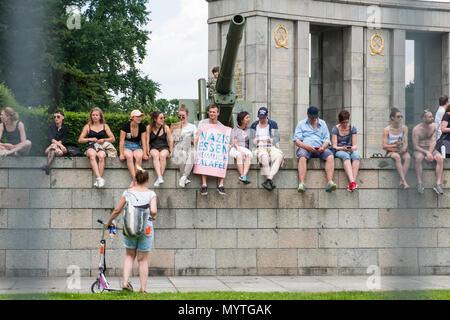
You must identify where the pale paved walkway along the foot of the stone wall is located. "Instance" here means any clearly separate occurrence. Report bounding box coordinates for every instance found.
[0,276,450,294]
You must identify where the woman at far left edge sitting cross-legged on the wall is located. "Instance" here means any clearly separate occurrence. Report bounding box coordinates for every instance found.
[0,107,31,157]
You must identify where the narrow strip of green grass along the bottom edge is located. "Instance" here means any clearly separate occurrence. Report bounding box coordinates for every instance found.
[0,290,450,300]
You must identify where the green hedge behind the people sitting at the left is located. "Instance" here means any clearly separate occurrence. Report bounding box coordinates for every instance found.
[0,83,178,156]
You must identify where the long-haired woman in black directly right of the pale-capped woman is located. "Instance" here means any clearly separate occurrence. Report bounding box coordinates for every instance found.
[147,110,173,187]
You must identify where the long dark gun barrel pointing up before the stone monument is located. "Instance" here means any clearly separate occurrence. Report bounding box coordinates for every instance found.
[216,14,245,94]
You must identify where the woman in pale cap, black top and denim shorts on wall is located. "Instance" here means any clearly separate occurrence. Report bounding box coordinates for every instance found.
[119,110,148,188]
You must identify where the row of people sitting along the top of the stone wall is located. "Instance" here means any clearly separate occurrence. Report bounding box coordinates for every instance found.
[0,92,450,195]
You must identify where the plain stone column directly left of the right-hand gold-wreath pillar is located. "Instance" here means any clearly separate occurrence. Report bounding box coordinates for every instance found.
[343,26,364,153]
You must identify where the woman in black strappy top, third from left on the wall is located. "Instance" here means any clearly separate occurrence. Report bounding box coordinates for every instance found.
[78,107,116,188]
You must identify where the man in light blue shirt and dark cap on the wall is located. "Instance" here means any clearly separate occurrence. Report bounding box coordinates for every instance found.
[293,106,336,192]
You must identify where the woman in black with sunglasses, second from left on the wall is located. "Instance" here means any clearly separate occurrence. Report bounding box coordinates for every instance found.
[42,110,69,174]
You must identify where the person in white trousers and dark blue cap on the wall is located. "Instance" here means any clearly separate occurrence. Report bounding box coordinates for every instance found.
[250,107,284,191]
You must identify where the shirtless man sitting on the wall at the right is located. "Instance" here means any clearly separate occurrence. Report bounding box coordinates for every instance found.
[412,110,444,194]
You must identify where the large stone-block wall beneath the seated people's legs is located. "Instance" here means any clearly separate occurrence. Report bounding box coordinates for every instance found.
[0,157,450,276]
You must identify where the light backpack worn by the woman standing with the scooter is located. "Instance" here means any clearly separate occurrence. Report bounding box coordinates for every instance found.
[123,192,150,237]
